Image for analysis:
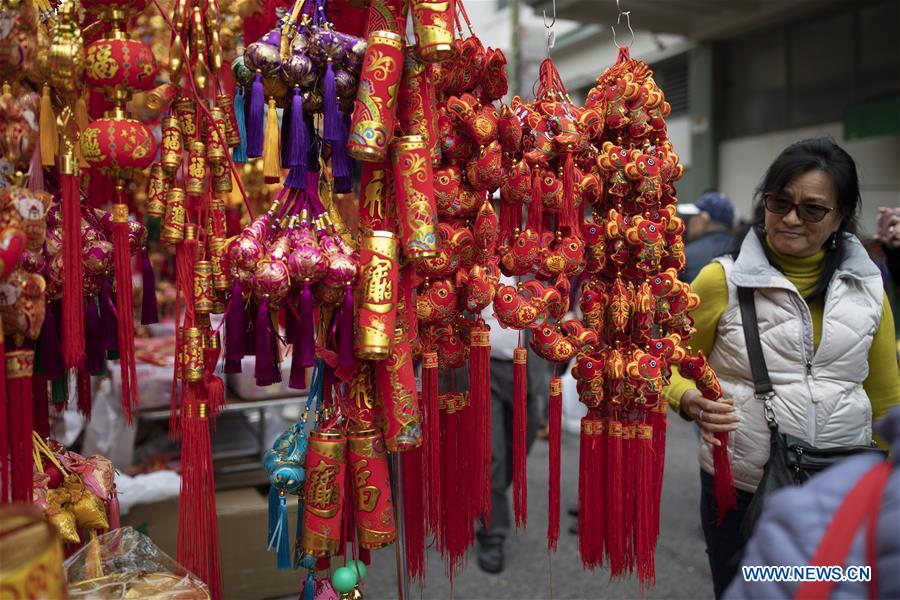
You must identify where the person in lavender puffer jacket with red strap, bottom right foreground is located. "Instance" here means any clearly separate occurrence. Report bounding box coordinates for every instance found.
[725,408,900,600]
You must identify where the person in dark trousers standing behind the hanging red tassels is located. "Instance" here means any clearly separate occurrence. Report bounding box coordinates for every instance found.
[477,276,550,573]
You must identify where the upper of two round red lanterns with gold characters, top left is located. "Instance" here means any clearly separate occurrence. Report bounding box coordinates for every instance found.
[84,39,159,90]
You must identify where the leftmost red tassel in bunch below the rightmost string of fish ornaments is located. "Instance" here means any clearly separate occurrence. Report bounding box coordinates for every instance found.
[578,416,606,569]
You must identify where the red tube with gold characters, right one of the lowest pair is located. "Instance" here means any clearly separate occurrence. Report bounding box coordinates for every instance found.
[347,429,397,550]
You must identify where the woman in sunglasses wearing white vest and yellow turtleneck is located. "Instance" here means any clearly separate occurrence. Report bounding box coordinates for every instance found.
[666,139,900,598]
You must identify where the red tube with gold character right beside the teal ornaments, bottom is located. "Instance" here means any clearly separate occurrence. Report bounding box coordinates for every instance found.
[300,430,347,557]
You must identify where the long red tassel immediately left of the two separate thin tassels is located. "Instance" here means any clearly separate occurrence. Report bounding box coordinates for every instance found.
[469,322,491,527]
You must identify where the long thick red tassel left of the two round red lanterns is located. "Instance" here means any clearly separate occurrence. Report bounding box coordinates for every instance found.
[60,168,85,368]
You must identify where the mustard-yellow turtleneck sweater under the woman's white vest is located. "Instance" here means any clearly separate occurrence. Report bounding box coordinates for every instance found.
[664,239,900,421]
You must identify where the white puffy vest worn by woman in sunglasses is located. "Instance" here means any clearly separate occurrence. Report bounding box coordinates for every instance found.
[700,233,884,492]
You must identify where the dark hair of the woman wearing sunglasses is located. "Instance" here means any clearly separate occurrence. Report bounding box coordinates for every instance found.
[733,137,862,300]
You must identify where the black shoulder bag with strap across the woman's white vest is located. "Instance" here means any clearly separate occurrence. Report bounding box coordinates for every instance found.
[738,287,887,538]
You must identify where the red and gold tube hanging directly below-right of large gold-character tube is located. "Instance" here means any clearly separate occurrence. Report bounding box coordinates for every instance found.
[375,329,422,452]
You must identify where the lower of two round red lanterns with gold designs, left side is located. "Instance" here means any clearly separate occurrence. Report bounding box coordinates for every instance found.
[81,117,156,169]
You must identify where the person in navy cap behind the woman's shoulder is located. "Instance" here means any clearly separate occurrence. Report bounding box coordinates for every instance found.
[681,192,735,283]
